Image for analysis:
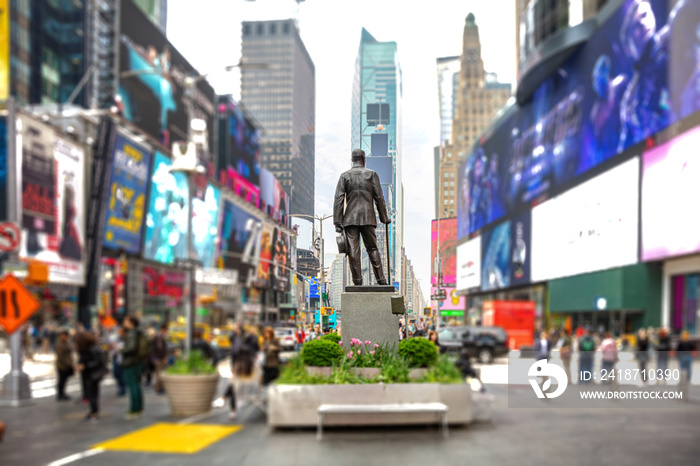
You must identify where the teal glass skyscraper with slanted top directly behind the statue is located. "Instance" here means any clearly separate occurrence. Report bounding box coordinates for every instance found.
[348,28,403,284]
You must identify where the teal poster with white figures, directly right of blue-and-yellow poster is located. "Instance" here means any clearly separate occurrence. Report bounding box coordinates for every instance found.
[143,152,189,264]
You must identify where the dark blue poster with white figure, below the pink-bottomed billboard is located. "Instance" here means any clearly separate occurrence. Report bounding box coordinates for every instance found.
[219,197,259,284]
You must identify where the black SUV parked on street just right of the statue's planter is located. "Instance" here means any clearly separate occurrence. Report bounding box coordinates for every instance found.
[438,326,508,364]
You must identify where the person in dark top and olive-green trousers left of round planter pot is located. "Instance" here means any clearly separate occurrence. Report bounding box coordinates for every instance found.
[122,316,149,420]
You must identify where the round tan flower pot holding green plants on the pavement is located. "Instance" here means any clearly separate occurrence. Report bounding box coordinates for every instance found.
[163,374,219,417]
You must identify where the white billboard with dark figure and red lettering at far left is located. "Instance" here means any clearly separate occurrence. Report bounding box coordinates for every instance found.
[18,116,85,285]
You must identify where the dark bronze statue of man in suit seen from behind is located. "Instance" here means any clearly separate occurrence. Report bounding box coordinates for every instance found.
[333,149,391,285]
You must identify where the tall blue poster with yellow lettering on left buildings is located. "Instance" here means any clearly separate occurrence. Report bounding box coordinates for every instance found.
[103,135,151,254]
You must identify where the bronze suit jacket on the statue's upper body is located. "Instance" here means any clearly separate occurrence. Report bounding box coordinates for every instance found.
[333,165,391,227]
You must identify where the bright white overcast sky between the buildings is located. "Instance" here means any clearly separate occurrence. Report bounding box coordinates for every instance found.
[167,0,516,299]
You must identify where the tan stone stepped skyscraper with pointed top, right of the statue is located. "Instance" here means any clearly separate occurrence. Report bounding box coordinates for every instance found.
[435,13,511,218]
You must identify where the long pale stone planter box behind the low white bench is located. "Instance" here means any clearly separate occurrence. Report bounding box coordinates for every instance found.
[267,383,472,427]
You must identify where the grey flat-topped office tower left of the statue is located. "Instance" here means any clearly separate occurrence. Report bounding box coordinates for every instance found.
[241,19,316,215]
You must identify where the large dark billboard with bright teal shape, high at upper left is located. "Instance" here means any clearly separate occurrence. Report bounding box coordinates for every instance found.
[118,2,215,147]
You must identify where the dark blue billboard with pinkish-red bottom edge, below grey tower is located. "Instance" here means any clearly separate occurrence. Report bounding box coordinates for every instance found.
[216,96,261,207]
